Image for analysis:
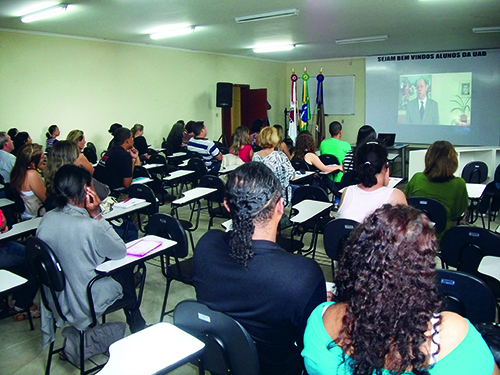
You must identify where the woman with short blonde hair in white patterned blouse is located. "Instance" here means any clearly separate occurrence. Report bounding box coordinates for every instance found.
[252,126,295,205]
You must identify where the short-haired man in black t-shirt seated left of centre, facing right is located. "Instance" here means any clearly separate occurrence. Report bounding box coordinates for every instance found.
[94,128,141,190]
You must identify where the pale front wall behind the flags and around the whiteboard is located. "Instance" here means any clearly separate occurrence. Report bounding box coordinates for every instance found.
[285,58,368,143]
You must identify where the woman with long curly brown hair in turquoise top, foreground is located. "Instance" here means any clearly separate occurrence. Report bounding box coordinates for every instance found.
[302,205,500,375]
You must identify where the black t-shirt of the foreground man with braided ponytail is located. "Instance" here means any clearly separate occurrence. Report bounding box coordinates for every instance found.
[194,230,326,375]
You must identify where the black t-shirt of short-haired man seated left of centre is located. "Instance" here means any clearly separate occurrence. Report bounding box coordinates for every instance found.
[94,146,133,190]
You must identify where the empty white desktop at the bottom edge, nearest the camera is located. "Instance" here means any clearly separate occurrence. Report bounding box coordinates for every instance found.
[99,322,205,375]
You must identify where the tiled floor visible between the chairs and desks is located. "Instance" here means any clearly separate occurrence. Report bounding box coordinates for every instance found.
[0,194,500,375]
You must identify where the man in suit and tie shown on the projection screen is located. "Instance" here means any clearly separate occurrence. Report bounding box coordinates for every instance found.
[406,78,439,125]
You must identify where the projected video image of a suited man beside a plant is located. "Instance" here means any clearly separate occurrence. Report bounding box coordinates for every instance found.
[398,72,472,126]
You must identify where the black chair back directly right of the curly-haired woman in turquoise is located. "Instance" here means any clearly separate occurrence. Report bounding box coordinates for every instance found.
[436,269,496,324]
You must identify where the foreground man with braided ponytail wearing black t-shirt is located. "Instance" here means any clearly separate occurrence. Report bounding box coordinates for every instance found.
[193,162,326,375]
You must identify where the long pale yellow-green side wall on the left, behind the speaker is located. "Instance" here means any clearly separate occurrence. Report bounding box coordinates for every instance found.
[0,30,289,150]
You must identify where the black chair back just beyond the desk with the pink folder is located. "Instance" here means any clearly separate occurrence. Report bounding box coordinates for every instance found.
[147,214,189,258]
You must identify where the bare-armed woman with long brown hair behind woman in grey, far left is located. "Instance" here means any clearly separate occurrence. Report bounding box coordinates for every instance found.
[10,143,46,220]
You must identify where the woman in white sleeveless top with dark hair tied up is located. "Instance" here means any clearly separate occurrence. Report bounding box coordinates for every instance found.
[339,141,407,222]
